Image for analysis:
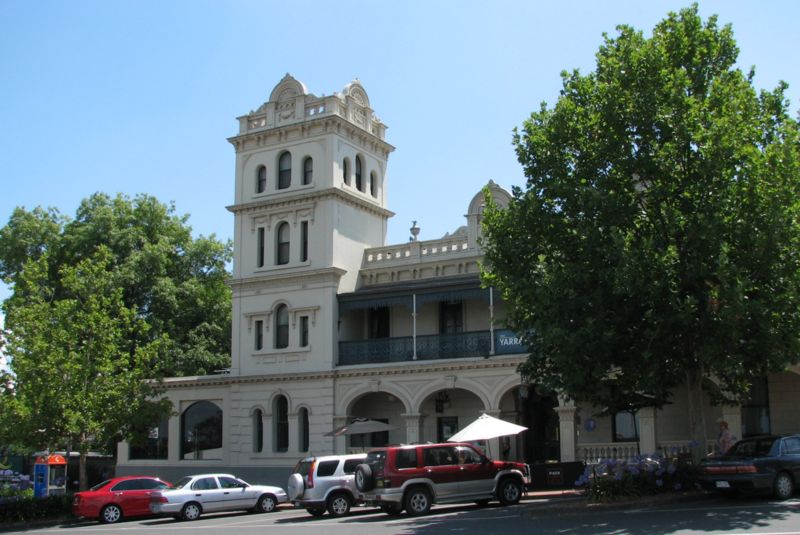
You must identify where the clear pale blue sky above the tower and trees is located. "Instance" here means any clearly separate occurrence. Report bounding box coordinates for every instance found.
[0,0,800,360]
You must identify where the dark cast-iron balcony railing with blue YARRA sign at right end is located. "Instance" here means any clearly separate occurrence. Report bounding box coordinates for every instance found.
[339,330,526,366]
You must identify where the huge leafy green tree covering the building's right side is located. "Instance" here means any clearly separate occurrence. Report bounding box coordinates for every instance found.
[484,5,800,456]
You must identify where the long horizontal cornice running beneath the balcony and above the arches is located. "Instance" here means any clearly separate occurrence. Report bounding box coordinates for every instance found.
[163,355,527,390]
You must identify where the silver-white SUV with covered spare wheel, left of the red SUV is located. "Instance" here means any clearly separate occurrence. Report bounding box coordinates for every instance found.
[287,453,367,516]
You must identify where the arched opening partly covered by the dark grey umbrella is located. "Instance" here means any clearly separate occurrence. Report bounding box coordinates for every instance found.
[347,392,406,451]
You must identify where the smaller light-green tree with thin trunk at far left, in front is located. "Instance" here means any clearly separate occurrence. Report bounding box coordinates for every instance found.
[0,245,171,489]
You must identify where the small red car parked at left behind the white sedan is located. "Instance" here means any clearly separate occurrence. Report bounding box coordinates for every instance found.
[72,476,172,524]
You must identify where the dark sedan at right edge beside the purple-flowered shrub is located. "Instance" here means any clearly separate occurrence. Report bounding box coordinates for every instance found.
[699,435,800,500]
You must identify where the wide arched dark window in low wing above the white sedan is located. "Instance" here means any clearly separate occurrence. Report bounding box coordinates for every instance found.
[181,401,222,459]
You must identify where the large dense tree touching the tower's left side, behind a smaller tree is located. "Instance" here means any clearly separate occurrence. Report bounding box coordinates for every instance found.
[0,193,231,376]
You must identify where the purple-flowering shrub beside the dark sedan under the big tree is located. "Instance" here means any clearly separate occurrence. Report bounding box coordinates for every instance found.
[575,453,696,502]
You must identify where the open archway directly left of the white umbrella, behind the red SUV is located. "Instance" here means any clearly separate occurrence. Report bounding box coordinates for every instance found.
[419,388,486,442]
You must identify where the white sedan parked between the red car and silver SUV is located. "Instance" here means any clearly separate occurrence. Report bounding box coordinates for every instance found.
[150,474,289,520]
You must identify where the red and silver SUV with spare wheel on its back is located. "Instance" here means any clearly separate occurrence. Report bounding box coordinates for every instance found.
[355,443,530,516]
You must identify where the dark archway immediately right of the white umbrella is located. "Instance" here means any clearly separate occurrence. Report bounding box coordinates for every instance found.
[500,385,561,464]
